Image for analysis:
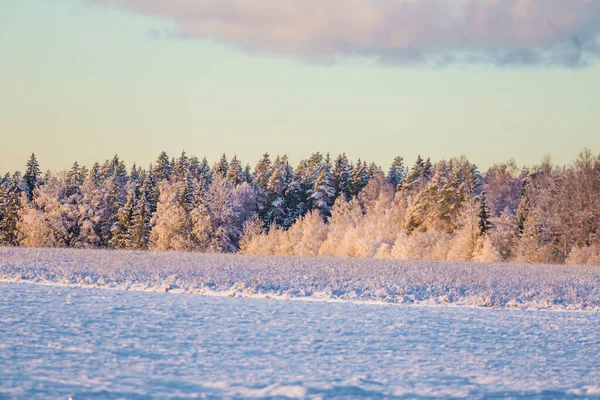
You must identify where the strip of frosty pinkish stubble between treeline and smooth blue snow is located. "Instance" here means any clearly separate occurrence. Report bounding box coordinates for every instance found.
[0,248,600,311]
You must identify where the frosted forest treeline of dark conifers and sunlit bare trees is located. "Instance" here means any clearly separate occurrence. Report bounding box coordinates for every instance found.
[0,150,600,265]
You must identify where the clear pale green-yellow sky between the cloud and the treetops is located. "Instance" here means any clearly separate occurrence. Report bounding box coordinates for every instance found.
[0,0,600,173]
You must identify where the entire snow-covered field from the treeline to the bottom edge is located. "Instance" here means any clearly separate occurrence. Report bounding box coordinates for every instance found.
[0,248,600,400]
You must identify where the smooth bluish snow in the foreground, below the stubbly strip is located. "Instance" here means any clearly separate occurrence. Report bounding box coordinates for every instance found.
[0,283,600,400]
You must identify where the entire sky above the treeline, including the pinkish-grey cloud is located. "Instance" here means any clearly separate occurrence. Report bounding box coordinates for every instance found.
[0,0,600,173]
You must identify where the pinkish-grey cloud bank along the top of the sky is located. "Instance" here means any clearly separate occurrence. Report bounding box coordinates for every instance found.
[92,0,600,67]
